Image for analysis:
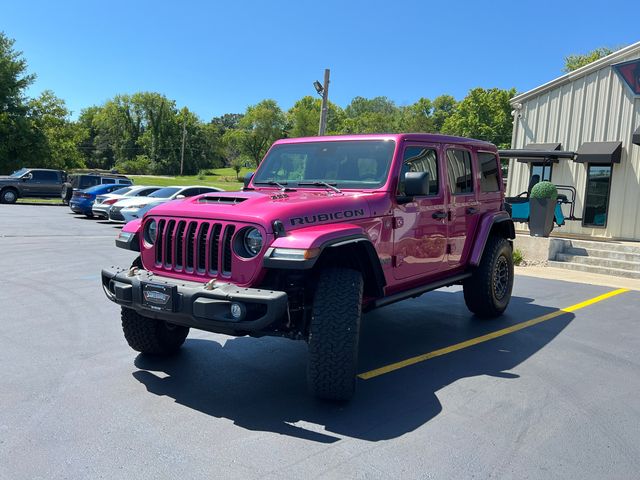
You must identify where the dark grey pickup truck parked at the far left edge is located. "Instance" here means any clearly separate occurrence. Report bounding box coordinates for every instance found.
[0,168,67,203]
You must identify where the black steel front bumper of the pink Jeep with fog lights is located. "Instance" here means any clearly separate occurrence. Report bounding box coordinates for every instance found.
[102,267,288,335]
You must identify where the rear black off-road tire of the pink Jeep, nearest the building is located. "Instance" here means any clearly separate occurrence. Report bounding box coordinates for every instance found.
[463,235,513,318]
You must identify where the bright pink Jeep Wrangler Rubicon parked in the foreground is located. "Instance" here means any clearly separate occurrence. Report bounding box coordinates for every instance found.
[102,134,514,400]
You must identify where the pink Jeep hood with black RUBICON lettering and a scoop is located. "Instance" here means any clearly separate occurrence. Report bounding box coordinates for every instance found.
[149,189,385,231]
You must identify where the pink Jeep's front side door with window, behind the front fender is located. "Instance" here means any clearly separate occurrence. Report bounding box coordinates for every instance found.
[393,144,447,279]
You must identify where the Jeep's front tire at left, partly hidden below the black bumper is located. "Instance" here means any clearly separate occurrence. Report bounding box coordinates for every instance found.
[122,307,189,356]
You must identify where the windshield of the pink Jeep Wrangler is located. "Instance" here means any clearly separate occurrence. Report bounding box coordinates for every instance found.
[253,140,395,189]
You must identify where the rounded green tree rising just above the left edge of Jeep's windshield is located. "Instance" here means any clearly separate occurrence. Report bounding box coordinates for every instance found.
[239,99,286,166]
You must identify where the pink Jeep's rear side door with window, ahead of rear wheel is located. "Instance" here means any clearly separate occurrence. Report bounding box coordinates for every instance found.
[445,146,480,268]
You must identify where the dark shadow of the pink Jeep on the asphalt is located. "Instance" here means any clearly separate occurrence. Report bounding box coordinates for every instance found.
[133,290,574,443]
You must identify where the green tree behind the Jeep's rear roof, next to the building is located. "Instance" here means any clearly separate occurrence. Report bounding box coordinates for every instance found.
[442,88,516,148]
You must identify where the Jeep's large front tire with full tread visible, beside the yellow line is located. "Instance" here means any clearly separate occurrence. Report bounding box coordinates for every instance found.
[307,267,364,401]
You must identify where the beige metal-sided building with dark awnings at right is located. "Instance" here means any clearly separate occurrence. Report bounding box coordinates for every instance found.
[507,42,640,241]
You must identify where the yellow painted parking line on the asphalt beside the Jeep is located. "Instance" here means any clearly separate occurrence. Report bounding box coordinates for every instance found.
[358,288,629,380]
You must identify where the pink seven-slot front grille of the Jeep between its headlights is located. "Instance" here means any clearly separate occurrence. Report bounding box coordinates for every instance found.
[152,218,236,277]
